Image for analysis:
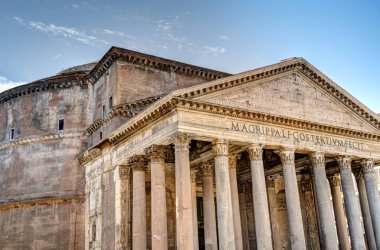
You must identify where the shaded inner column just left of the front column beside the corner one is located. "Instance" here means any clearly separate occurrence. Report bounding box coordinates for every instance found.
[201,164,218,250]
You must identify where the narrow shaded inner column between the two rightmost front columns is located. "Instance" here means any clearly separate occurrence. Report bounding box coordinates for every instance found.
[355,172,376,250]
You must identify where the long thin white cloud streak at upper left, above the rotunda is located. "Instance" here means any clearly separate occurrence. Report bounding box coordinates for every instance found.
[13,16,109,45]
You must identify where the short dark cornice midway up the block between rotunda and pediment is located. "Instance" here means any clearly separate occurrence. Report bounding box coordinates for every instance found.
[86,95,164,135]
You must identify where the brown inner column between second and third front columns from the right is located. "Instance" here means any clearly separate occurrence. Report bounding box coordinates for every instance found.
[330,176,350,250]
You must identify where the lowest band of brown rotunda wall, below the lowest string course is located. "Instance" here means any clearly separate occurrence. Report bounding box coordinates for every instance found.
[0,200,84,250]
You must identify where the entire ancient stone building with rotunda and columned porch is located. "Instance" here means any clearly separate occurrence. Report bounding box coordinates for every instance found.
[0,47,380,250]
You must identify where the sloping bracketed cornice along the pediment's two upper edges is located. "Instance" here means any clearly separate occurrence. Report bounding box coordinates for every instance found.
[178,58,380,132]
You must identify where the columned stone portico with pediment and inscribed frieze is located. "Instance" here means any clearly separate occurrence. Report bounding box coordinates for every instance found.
[80,57,380,249]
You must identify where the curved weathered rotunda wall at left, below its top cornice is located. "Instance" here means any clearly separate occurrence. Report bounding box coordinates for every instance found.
[0,85,87,249]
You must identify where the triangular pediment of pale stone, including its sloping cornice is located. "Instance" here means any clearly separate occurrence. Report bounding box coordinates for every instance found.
[174,59,380,134]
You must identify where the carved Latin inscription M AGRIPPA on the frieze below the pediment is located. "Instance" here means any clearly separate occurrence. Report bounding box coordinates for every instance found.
[231,122,364,150]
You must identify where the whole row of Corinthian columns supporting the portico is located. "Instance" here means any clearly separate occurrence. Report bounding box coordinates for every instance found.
[129,133,380,249]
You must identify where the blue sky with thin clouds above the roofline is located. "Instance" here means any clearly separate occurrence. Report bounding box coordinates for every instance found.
[0,0,380,113]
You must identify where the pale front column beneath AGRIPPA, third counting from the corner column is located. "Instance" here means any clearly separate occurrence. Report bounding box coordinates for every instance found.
[248,145,273,249]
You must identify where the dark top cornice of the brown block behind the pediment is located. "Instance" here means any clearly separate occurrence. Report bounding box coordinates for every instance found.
[86,47,230,84]
